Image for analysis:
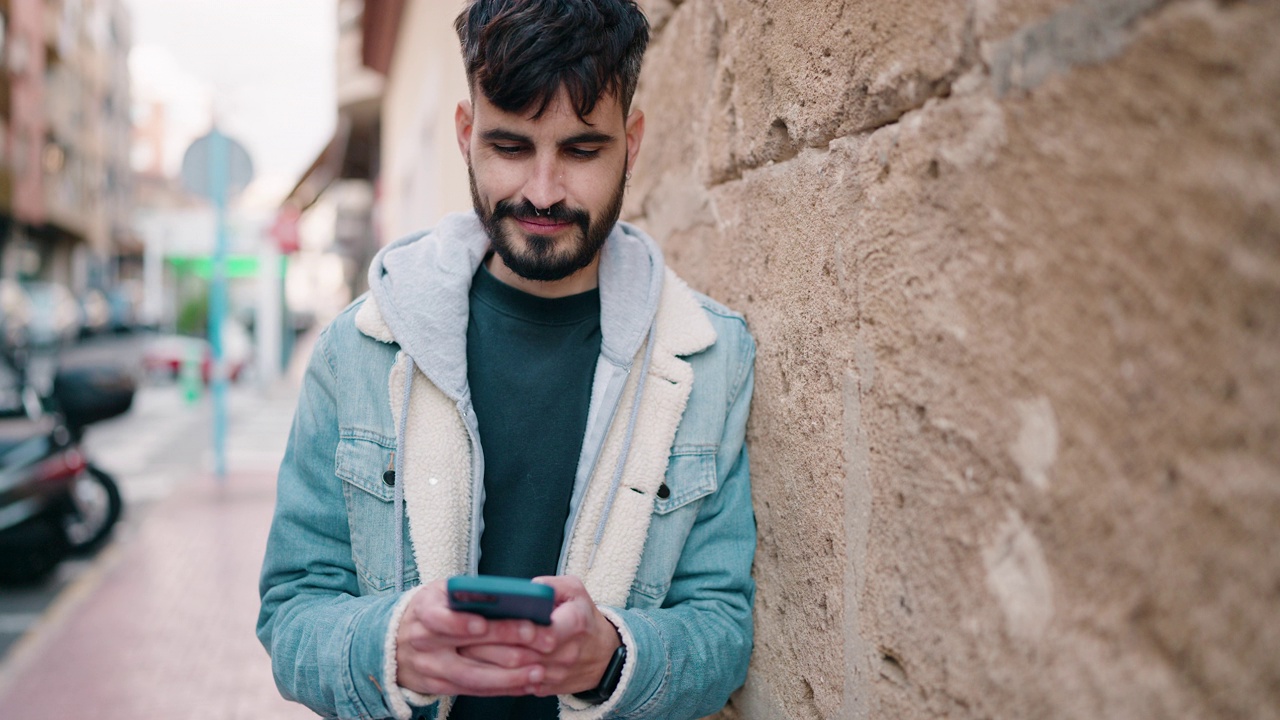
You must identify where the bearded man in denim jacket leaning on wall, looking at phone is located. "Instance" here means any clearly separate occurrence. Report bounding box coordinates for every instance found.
[257,0,755,719]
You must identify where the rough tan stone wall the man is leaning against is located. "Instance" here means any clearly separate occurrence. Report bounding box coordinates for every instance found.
[626,0,1280,720]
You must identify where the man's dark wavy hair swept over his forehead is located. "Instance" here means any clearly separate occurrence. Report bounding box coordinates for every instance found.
[453,0,649,118]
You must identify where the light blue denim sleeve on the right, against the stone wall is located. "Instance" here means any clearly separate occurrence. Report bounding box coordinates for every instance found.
[583,333,755,719]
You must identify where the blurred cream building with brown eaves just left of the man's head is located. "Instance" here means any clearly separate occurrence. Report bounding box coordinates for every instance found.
[287,0,471,271]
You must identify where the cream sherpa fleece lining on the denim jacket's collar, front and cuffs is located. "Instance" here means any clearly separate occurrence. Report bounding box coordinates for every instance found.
[356,269,716,720]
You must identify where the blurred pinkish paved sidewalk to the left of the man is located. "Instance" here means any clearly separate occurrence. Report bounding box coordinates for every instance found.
[0,371,315,720]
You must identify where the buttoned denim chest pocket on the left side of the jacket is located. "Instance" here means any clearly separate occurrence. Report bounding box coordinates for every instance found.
[334,430,417,594]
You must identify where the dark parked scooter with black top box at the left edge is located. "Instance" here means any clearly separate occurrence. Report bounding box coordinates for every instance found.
[0,366,137,583]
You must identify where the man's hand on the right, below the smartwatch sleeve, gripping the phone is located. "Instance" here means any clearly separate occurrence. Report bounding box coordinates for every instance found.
[458,575,622,696]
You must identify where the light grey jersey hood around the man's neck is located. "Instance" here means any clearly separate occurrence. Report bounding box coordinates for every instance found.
[369,213,663,401]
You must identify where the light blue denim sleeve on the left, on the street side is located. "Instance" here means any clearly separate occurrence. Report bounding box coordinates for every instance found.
[257,331,432,719]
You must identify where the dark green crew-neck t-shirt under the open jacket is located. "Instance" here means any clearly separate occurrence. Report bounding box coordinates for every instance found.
[449,265,600,720]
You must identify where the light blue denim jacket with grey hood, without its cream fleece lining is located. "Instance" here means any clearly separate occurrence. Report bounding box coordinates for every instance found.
[257,214,755,719]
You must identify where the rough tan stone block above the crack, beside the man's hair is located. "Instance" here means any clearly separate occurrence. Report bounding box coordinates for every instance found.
[629,0,977,193]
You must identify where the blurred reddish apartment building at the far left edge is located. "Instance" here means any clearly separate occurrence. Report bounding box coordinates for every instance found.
[0,0,133,293]
